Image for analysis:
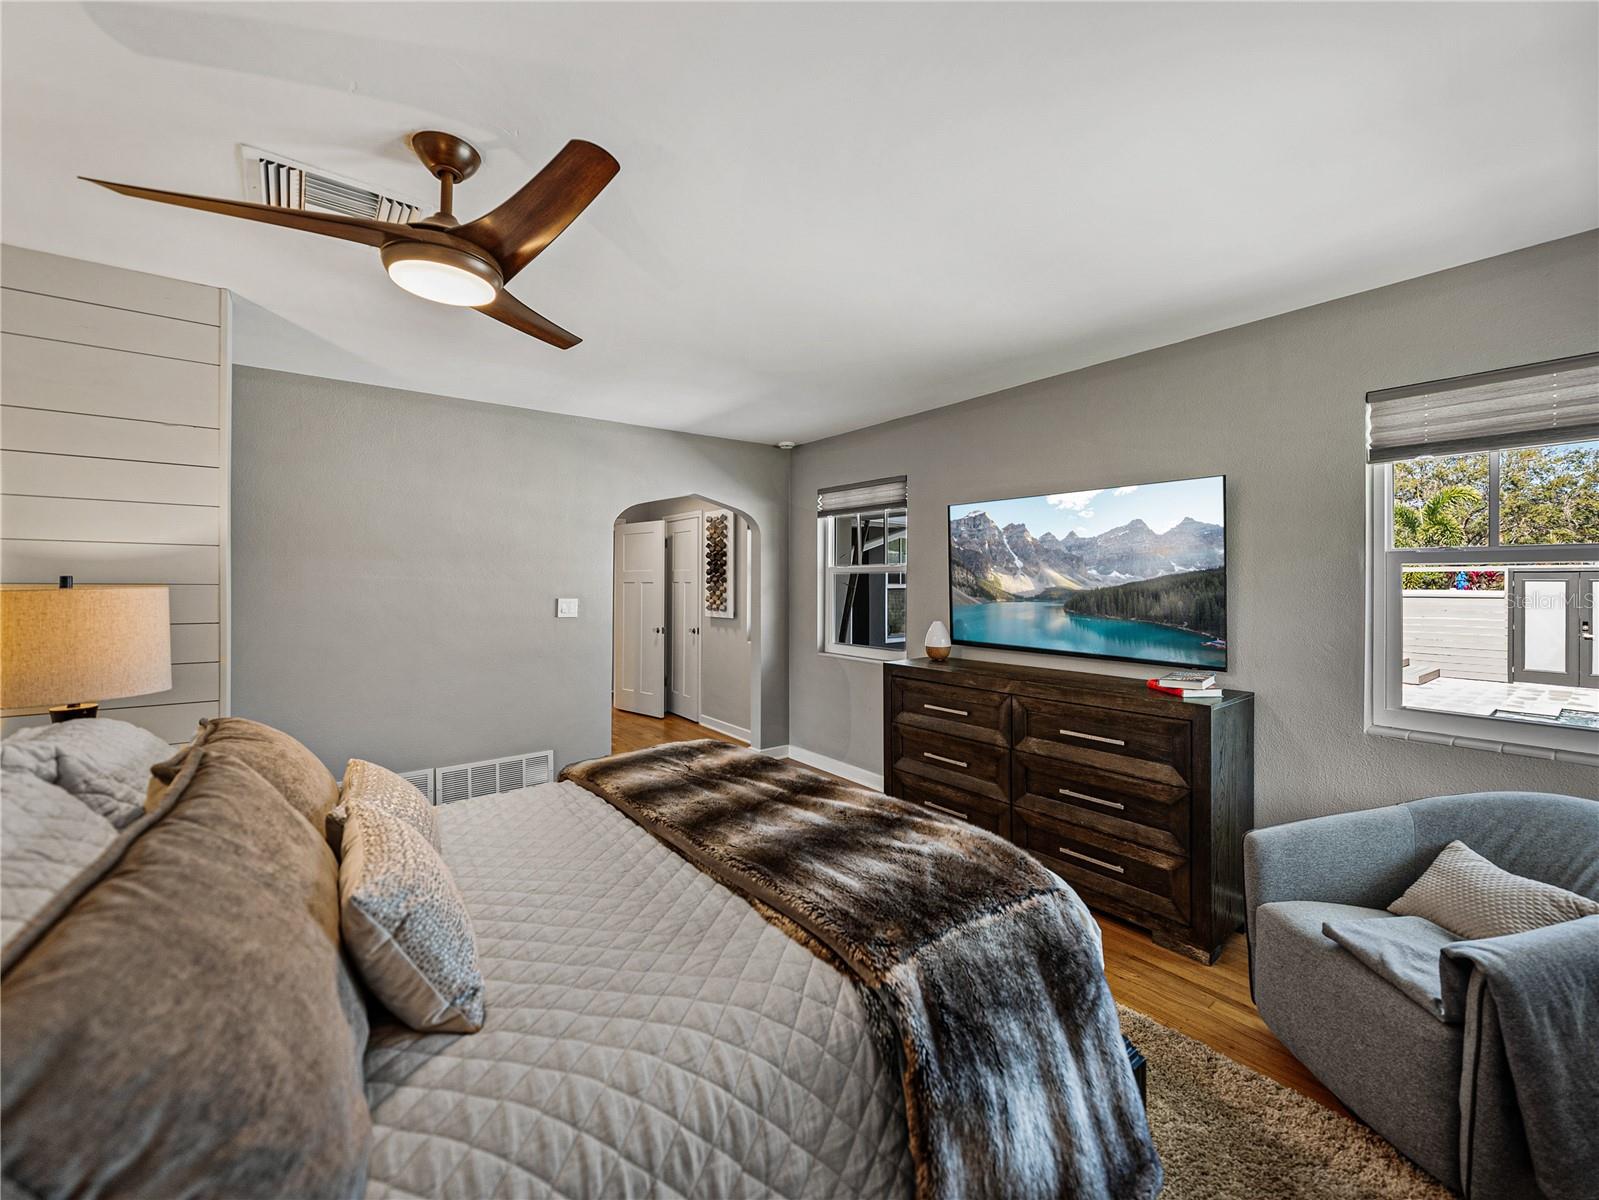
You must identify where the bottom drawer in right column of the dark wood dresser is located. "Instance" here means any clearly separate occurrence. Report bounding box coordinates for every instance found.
[1012,808,1190,922]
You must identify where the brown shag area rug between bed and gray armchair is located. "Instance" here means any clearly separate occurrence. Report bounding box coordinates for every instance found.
[1118,1005,1455,1200]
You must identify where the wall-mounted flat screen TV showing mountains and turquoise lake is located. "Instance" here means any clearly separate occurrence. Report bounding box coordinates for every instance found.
[950,475,1226,670]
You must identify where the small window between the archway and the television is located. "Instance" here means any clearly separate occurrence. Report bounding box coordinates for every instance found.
[817,478,910,658]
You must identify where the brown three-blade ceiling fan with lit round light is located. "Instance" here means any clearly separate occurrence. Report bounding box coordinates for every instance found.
[80,130,620,350]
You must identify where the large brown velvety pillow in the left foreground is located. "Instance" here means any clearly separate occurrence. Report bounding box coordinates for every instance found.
[0,752,371,1200]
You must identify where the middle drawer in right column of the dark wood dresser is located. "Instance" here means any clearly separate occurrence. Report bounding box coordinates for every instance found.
[1012,754,1191,856]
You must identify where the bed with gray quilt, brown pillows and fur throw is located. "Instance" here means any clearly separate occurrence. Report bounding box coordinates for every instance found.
[0,718,1159,1200]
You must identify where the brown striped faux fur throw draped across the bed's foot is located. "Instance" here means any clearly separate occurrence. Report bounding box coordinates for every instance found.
[563,741,1161,1200]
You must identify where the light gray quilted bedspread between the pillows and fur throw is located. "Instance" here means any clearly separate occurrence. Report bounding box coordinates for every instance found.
[366,784,911,1200]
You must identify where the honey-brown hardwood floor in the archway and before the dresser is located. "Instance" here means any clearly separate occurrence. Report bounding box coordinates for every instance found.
[611,710,1345,1112]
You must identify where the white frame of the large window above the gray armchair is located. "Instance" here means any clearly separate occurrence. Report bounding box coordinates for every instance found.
[1366,462,1599,765]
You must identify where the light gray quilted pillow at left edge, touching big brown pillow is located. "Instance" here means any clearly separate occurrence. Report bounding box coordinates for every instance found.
[0,768,117,942]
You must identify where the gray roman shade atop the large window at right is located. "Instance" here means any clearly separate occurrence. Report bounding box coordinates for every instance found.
[1366,354,1599,462]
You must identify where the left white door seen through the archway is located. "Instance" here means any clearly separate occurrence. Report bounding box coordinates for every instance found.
[611,522,667,717]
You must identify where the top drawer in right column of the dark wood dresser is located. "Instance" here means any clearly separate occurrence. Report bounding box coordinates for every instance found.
[1011,696,1190,786]
